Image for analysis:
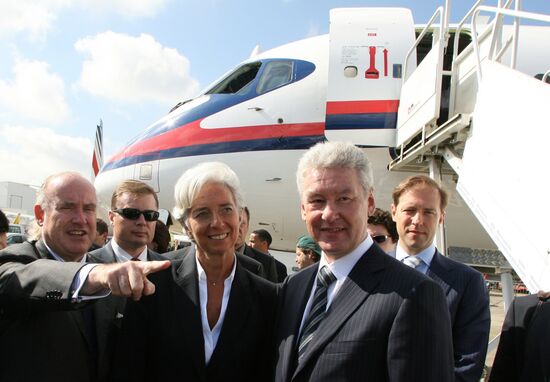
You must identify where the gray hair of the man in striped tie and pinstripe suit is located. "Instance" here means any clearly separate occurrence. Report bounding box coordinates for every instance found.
[296,142,373,195]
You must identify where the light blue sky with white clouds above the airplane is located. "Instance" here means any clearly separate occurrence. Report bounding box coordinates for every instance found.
[0,0,550,185]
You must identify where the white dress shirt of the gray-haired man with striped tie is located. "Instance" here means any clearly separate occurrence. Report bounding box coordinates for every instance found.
[298,235,373,334]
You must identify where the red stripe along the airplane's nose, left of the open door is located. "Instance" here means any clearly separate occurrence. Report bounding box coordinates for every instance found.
[105,119,325,163]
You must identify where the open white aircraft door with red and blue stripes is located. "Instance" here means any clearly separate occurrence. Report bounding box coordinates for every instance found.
[325,8,416,147]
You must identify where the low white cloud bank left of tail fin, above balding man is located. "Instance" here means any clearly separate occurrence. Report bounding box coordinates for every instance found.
[0,125,92,185]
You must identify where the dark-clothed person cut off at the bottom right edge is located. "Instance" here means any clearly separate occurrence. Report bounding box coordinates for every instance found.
[489,292,550,382]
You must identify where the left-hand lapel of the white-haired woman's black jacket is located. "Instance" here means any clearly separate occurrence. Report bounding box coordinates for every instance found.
[173,249,206,380]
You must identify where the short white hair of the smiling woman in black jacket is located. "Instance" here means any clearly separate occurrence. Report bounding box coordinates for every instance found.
[173,162,244,230]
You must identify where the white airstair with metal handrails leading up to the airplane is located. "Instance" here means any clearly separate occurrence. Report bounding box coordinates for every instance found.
[389,0,550,296]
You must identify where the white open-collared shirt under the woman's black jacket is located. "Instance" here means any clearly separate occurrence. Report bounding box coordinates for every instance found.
[195,251,237,365]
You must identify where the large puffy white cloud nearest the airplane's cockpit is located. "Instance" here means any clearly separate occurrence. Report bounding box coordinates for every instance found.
[75,31,199,105]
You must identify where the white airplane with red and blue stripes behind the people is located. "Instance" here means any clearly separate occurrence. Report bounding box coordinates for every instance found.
[95,2,550,262]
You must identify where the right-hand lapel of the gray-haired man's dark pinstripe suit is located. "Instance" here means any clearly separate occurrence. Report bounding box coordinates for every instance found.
[294,246,387,377]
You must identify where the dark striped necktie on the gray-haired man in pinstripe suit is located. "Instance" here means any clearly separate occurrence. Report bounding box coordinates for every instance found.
[298,265,336,361]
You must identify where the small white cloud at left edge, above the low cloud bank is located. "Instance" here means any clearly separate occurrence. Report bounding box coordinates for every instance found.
[0,58,69,123]
